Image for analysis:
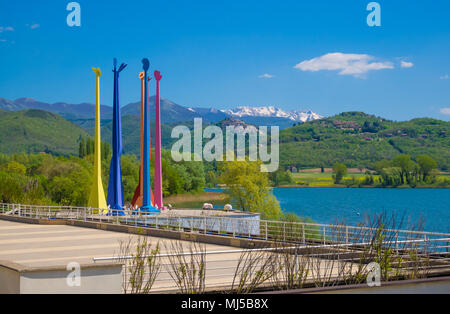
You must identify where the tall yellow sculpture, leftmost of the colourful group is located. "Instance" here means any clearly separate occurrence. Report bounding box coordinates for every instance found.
[88,68,107,214]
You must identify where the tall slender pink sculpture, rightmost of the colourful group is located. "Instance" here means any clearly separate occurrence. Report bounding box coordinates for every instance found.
[154,71,163,208]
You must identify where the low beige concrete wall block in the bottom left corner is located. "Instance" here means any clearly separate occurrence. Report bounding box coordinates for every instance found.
[0,261,123,294]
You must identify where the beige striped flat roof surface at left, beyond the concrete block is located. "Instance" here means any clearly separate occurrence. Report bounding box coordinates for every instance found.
[0,220,239,267]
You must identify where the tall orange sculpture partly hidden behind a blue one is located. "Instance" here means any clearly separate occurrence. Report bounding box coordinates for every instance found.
[131,72,154,207]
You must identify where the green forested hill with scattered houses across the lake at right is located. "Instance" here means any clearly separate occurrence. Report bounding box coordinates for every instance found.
[280,112,450,170]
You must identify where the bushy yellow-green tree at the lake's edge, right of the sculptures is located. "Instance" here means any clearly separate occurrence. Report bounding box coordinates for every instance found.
[220,160,282,220]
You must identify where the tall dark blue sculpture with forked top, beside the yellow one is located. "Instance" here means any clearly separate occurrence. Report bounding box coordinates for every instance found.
[107,58,127,216]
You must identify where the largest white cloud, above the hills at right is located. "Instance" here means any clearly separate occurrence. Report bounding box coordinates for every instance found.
[294,52,394,77]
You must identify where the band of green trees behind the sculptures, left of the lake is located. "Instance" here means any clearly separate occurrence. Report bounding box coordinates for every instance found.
[0,149,205,206]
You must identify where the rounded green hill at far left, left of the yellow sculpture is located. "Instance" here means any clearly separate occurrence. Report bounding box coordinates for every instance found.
[0,109,87,154]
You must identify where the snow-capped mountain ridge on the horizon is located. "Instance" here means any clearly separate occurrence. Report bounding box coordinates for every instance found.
[221,106,323,122]
